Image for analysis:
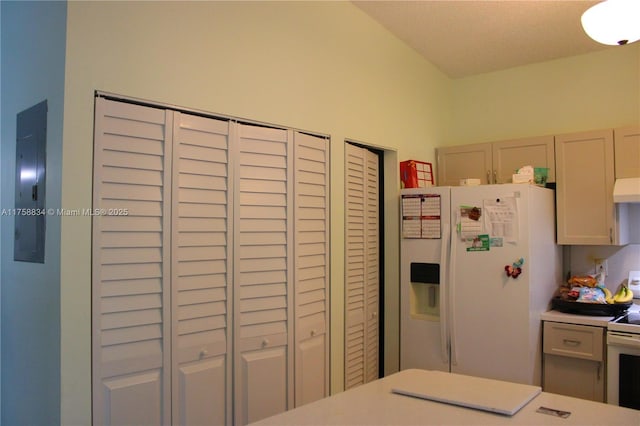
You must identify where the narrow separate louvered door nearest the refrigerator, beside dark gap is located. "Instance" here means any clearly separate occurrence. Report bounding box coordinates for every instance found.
[345,144,380,389]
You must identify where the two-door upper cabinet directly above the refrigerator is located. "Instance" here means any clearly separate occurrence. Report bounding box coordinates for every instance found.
[436,136,555,186]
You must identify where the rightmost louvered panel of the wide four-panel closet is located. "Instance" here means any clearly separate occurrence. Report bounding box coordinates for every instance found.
[294,133,329,407]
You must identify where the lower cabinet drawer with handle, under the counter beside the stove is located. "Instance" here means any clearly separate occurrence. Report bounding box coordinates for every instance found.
[543,321,604,361]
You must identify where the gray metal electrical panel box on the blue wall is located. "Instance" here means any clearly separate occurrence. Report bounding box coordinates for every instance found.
[12,100,47,263]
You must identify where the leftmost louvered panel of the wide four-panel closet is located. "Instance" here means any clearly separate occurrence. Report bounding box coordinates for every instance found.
[92,98,172,425]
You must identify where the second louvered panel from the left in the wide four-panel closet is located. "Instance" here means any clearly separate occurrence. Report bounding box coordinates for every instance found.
[171,112,232,425]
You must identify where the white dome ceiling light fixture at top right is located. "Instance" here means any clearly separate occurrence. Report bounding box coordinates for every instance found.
[582,0,640,46]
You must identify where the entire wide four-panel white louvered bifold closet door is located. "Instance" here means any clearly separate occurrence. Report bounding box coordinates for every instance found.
[92,97,329,425]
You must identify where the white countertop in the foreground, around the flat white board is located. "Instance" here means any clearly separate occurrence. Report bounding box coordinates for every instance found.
[253,370,640,426]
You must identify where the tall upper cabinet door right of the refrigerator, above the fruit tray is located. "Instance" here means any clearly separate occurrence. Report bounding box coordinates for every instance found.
[555,130,617,245]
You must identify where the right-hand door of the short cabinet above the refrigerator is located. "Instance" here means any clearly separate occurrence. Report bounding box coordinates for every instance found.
[492,136,556,183]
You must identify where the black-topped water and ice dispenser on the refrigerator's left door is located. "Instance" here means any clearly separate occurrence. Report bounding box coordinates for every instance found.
[409,262,440,321]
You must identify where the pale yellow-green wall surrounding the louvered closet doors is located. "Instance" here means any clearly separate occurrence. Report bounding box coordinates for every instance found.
[61,1,451,425]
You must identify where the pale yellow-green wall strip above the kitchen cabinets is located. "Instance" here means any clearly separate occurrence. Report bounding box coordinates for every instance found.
[446,43,640,145]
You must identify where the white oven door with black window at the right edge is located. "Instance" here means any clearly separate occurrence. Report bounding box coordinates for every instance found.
[607,331,640,409]
